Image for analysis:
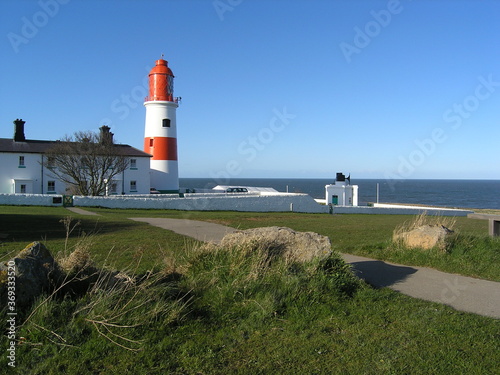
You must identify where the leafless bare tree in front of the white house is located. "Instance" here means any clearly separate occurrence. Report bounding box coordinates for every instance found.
[43,126,129,195]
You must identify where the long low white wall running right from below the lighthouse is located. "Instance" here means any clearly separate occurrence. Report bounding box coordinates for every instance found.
[74,194,328,213]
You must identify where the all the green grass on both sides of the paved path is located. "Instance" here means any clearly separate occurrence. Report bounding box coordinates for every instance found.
[0,206,500,374]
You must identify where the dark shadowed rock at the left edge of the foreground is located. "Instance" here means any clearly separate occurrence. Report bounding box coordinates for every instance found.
[0,242,61,309]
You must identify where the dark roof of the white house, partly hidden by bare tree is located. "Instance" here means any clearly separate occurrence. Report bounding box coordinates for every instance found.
[0,138,152,158]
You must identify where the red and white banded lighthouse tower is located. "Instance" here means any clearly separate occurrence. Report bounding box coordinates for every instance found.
[144,55,179,194]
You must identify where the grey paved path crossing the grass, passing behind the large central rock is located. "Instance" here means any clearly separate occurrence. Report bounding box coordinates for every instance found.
[131,218,500,319]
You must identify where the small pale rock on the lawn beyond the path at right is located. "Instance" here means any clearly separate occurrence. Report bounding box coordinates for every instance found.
[393,225,453,251]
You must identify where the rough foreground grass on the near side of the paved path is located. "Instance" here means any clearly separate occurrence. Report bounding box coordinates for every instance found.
[0,211,500,374]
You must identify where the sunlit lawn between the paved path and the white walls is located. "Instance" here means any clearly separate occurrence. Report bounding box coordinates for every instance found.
[56,209,500,281]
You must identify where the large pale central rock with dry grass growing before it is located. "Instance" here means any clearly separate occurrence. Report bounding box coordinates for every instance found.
[220,227,332,262]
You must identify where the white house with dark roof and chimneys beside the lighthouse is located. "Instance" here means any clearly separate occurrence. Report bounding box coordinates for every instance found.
[0,119,151,195]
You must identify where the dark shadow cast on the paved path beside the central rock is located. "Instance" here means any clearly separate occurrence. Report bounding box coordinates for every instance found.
[351,260,417,288]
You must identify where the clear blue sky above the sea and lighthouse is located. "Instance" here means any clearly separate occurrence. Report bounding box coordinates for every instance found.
[0,0,500,179]
